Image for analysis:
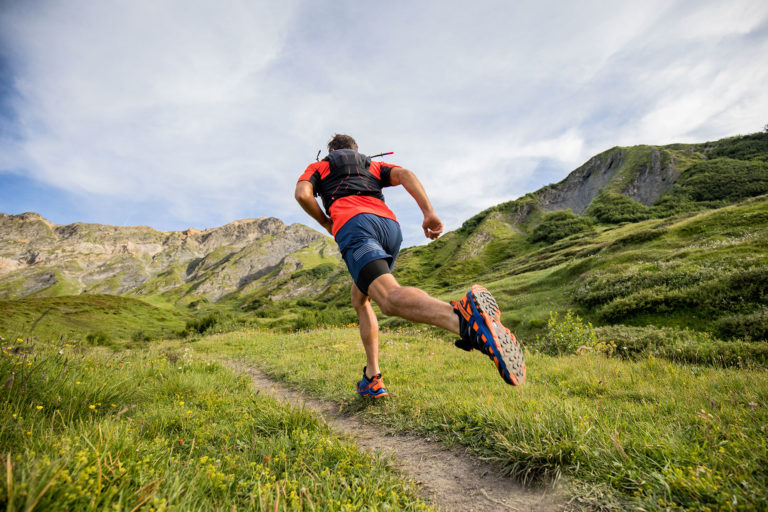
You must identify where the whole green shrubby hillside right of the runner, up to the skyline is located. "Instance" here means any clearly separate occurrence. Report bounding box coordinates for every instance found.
[395,134,768,339]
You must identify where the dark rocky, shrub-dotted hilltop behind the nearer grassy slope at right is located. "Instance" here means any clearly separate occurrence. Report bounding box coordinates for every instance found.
[406,133,768,274]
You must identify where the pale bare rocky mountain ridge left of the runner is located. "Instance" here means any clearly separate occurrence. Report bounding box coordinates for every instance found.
[0,213,339,301]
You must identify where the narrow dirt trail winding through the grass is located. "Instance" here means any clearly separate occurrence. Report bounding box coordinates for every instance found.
[227,361,565,512]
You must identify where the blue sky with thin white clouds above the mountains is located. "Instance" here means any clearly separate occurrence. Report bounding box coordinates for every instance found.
[0,0,768,246]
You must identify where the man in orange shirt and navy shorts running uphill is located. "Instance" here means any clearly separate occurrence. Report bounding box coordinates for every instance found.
[295,134,525,398]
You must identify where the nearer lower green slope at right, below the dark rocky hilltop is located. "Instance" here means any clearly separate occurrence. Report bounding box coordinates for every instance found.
[394,196,768,341]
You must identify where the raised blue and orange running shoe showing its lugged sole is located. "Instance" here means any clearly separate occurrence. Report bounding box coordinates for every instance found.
[451,285,525,386]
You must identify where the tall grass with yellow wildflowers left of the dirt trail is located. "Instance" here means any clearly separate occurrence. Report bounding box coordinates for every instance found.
[0,339,426,511]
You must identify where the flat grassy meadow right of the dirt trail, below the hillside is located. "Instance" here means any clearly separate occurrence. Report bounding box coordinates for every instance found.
[195,328,768,510]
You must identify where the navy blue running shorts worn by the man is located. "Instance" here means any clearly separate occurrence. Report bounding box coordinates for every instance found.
[336,213,403,293]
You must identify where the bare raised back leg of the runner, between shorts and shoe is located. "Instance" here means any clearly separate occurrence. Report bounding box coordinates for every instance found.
[368,274,459,334]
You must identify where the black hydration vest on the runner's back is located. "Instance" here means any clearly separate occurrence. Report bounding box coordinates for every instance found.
[315,149,384,215]
